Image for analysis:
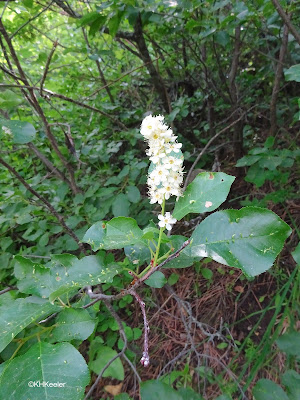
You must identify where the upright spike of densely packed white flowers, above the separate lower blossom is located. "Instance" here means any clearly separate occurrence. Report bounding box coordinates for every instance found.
[141,115,183,204]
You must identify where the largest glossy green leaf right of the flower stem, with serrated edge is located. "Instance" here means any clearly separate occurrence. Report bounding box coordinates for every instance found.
[190,207,291,276]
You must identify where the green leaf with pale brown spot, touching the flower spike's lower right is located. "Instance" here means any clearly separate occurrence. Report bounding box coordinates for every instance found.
[173,172,235,220]
